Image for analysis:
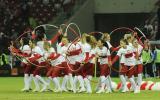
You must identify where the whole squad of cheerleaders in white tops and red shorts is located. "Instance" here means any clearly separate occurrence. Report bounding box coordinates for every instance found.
[10,32,144,93]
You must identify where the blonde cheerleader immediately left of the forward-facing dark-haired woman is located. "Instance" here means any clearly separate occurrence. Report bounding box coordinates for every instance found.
[77,33,96,93]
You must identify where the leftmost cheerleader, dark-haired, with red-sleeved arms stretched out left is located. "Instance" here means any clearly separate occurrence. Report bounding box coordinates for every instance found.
[9,38,33,92]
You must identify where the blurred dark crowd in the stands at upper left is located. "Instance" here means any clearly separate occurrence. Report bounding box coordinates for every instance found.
[0,0,75,54]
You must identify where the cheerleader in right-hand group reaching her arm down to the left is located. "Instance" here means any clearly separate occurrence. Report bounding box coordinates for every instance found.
[112,39,139,93]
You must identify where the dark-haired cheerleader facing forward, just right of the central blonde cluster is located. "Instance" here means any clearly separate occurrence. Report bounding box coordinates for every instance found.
[96,40,112,93]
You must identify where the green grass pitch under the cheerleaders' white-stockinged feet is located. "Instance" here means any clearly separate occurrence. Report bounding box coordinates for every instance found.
[0,77,160,100]
